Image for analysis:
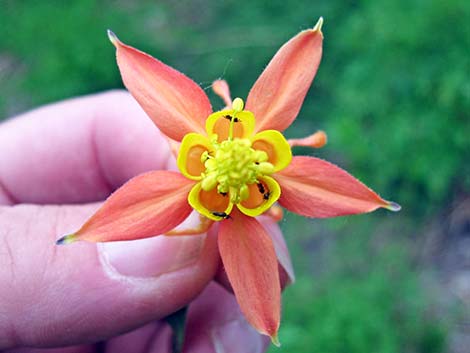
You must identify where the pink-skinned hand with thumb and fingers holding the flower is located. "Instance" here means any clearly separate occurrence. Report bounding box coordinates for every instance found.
[0,91,290,353]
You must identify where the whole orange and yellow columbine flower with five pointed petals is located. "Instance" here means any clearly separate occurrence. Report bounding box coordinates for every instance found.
[58,18,399,343]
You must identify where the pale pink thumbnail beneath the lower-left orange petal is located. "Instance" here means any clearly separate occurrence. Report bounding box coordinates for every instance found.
[98,235,206,278]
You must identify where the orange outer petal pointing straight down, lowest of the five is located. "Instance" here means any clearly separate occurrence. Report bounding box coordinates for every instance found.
[218,210,281,342]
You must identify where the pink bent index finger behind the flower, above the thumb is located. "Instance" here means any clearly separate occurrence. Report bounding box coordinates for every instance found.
[0,91,170,204]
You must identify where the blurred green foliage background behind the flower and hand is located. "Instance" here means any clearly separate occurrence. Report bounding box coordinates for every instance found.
[0,0,470,353]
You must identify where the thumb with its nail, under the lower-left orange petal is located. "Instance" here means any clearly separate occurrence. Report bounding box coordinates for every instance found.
[0,205,218,350]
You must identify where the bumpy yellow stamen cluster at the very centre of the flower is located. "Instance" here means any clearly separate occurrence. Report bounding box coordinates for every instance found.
[201,139,274,203]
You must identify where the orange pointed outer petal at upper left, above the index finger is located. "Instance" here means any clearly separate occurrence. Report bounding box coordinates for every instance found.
[108,30,212,141]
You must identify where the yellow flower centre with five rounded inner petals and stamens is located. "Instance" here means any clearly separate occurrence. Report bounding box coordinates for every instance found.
[177,98,292,221]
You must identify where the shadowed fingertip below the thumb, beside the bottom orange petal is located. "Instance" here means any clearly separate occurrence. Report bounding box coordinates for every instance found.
[183,282,269,353]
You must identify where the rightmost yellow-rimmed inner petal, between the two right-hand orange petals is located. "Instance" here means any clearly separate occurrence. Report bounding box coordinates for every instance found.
[252,130,292,172]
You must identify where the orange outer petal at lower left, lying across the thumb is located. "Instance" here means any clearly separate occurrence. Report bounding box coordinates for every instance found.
[57,171,194,244]
